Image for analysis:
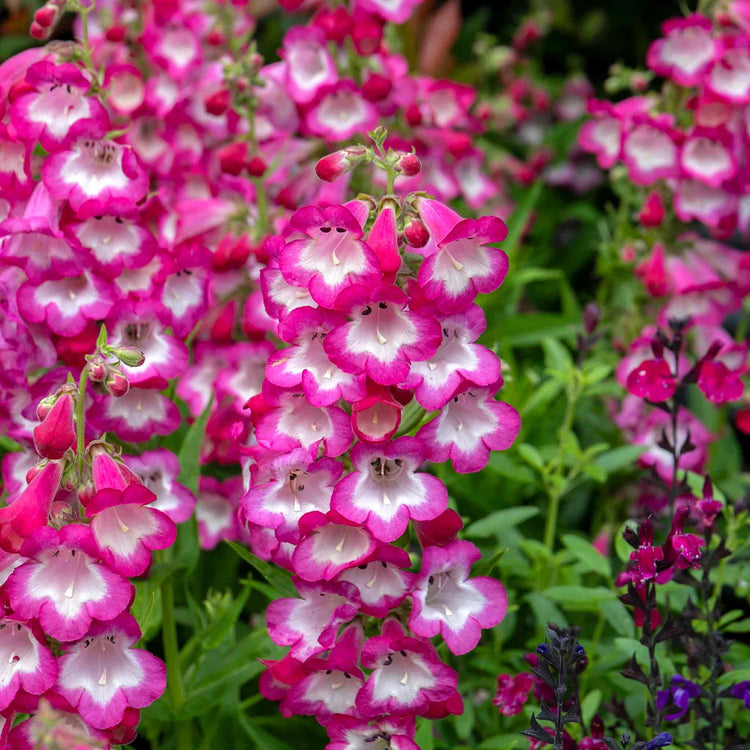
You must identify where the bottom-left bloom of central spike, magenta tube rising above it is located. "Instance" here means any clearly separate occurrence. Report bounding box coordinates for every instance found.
[282,623,365,724]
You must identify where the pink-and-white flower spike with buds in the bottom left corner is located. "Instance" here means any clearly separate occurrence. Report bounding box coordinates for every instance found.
[0,342,183,747]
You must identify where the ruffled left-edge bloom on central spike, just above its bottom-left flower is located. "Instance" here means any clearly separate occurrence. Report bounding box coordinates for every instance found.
[266,578,360,660]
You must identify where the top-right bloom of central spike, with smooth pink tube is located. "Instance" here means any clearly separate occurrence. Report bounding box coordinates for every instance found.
[417,198,508,313]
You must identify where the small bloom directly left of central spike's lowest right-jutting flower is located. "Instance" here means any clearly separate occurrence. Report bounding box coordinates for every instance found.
[336,544,415,618]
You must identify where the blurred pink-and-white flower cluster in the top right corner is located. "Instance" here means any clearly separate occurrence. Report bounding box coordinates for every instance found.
[580,8,750,236]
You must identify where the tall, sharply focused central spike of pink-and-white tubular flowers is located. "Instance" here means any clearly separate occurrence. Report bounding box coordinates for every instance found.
[240,140,520,748]
